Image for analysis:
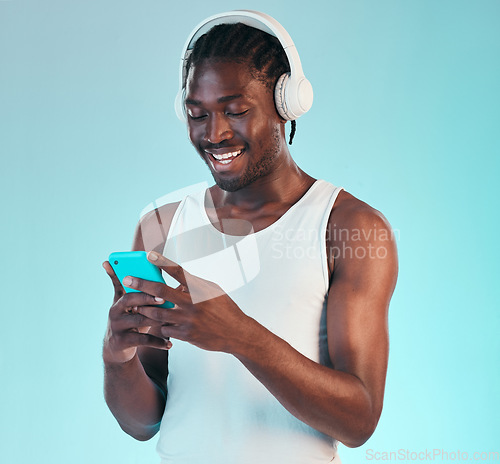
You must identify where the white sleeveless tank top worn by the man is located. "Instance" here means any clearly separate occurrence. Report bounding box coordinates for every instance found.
[157,180,341,464]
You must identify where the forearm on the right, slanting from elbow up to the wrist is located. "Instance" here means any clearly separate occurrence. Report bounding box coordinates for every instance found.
[233,320,378,447]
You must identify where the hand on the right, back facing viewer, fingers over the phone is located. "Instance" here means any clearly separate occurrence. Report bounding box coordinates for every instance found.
[125,252,251,352]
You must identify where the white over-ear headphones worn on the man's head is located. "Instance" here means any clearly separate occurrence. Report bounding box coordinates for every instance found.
[175,10,313,122]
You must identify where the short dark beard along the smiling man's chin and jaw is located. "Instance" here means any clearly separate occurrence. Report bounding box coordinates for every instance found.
[207,128,281,192]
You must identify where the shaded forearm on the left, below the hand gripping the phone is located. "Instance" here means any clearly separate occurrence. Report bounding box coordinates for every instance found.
[104,355,166,441]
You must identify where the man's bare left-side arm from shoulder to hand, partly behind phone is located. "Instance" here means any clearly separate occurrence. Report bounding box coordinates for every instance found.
[103,204,177,440]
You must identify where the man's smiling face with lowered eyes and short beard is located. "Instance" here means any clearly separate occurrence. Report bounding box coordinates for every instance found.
[186,60,287,192]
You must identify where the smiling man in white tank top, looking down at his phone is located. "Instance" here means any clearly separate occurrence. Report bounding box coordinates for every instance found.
[103,11,397,464]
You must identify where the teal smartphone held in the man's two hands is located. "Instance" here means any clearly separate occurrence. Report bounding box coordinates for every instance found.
[108,251,174,308]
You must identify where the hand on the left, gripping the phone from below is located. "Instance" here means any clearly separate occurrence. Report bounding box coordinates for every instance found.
[103,261,172,363]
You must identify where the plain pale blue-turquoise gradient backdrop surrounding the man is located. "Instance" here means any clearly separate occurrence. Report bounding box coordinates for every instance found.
[0,0,500,464]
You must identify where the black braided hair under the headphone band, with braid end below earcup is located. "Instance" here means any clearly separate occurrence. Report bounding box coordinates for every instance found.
[187,23,296,145]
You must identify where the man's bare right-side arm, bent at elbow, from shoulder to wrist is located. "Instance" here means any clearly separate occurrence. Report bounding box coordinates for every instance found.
[233,200,397,447]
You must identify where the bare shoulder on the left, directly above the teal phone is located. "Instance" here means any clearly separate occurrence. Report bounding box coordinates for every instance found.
[132,202,180,253]
